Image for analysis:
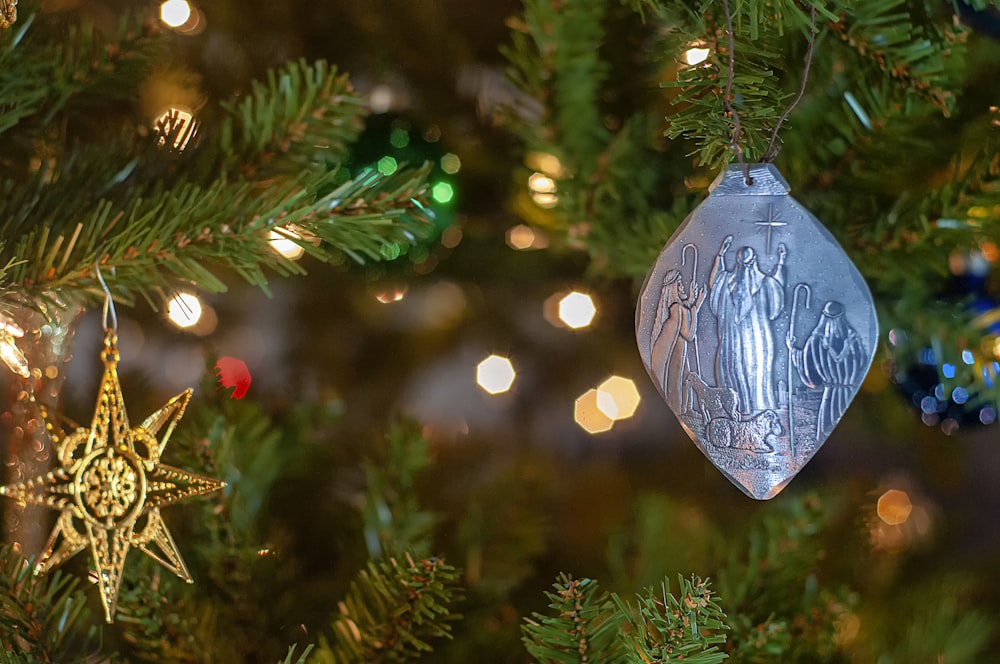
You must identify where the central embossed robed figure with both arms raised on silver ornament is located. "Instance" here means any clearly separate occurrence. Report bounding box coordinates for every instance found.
[708,235,788,415]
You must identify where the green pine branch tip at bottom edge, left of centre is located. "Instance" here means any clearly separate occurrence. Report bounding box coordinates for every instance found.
[315,556,461,664]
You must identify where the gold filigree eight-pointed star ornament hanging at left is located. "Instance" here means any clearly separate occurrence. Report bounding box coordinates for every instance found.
[0,329,226,623]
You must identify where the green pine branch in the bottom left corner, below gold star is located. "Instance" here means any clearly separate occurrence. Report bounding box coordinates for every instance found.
[0,544,106,664]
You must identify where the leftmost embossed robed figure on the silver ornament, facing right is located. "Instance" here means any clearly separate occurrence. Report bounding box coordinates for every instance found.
[651,270,706,414]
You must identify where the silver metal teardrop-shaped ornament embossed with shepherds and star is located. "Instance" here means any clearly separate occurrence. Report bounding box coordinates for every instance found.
[636,164,878,499]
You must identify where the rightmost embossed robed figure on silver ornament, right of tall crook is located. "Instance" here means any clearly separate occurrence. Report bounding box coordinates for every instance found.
[788,300,868,439]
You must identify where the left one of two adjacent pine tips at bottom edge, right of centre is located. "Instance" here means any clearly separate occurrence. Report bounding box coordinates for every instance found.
[521,574,626,664]
